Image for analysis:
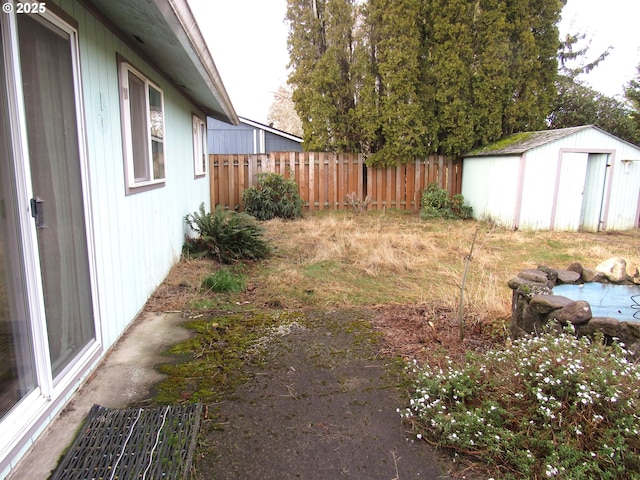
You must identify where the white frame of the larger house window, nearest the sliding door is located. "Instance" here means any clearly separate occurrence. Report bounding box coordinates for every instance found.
[119,60,167,194]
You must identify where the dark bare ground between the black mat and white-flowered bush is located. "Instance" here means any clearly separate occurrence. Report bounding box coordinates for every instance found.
[196,311,456,480]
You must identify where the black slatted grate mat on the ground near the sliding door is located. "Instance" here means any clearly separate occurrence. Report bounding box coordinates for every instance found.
[50,404,202,480]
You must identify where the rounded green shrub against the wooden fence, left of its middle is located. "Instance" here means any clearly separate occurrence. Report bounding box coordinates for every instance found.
[242,173,302,220]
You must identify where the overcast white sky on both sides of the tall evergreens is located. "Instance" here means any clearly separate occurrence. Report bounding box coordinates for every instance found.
[188,0,640,123]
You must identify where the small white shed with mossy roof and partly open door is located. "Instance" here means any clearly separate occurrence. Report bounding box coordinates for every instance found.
[462,125,640,232]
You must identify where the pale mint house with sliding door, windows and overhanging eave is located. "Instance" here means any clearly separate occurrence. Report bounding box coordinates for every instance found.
[0,0,238,479]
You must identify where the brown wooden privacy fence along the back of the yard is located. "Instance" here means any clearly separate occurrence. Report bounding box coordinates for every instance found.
[209,152,462,210]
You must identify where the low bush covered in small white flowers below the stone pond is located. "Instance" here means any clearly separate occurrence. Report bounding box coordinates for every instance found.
[400,324,640,479]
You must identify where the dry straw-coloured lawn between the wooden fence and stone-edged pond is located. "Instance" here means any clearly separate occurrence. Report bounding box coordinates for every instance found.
[150,212,640,338]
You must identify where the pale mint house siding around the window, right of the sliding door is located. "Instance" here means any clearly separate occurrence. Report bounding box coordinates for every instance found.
[51,1,209,349]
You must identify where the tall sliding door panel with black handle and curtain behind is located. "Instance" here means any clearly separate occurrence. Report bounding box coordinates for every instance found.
[17,15,95,377]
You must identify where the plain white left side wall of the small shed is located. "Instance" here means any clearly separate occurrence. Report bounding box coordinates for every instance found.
[462,156,519,228]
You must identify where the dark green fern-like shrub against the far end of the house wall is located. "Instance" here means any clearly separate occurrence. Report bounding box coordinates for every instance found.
[184,203,270,263]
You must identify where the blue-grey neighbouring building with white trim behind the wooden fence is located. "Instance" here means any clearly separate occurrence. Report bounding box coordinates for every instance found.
[207,117,302,154]
